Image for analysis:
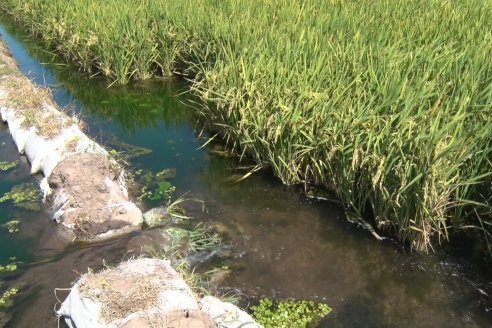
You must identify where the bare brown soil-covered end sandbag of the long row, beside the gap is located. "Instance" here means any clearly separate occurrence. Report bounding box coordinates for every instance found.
[47,154,142,240]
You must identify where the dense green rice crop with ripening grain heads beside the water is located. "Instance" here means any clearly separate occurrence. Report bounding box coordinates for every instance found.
[0,0,492,255]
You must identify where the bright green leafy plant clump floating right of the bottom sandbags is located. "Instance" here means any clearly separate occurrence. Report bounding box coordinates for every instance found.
[251,298,331,328]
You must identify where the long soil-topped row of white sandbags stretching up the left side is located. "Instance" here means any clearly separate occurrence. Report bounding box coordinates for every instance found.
[0,42,142,240]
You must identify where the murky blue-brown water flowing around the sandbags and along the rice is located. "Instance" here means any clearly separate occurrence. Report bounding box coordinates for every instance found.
[0,20,492,327]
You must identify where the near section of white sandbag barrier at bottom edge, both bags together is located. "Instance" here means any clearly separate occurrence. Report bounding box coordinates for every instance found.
[57,258,263,328]
